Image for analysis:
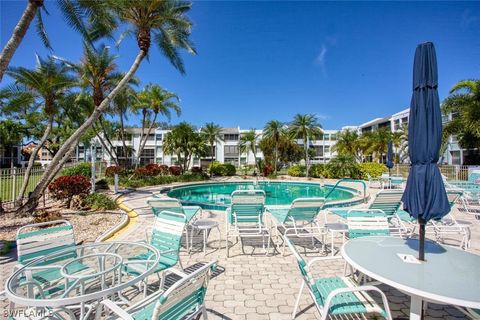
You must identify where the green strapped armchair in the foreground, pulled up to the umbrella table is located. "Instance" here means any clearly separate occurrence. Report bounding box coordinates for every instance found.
[285,238,392,320]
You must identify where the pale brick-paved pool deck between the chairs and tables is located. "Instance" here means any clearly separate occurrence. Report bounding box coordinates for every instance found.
[0,178,480,320]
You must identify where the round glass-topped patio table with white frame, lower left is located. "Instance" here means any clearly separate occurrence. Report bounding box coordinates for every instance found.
[5,241,160,319]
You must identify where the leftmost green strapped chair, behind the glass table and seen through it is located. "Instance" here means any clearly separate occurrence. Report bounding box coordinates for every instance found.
[15,220,86,283]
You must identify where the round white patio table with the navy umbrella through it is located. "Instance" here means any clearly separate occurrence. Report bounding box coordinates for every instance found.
[341,237,480,320]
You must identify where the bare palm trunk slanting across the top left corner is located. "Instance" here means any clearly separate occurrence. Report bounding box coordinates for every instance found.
[0,0,43,81]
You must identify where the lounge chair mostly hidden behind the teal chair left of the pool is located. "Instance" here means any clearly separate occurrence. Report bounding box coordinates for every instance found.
[147,196,202,251]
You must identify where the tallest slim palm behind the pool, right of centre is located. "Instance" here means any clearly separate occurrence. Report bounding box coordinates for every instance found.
[289,114,322,177]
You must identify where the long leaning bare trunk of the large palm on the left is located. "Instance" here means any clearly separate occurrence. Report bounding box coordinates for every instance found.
[17,50,146,213]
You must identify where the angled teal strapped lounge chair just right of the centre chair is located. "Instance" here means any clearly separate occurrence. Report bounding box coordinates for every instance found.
[267,198,325,254]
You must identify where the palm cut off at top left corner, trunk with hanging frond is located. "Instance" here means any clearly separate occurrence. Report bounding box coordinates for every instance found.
[0,0,51,82]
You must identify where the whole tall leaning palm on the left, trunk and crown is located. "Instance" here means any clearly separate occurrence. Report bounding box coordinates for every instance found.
[19,0,196,215]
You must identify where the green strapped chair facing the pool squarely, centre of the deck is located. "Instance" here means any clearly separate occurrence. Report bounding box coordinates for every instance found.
[225,190,270,257]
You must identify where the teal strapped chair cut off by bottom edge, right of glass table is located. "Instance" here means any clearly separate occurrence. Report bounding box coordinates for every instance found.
[102,261,216,320]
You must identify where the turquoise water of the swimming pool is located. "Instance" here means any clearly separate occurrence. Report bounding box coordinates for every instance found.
[166,181,358,209]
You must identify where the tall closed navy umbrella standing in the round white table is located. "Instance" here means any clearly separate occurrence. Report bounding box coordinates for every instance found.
[402,42,450,260]
